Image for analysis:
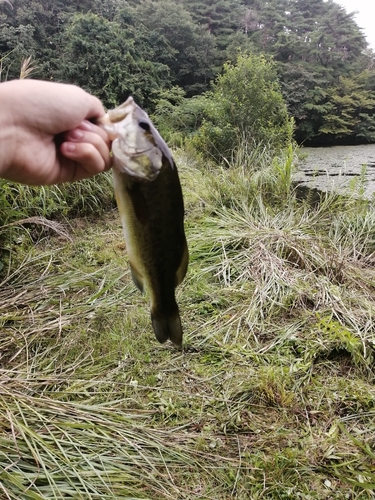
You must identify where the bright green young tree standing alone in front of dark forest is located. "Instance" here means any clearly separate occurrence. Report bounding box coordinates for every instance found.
[193,55,293,159]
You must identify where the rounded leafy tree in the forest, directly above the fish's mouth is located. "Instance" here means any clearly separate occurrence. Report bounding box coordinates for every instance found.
[56,14,168,107]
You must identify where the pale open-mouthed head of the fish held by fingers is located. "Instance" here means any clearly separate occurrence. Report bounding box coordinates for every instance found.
[98,97,173,181]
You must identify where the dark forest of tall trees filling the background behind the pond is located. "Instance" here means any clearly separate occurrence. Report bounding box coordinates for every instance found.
[0,0,375,145]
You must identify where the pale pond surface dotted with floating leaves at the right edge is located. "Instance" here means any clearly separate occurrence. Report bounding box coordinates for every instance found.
[294,144,375,198]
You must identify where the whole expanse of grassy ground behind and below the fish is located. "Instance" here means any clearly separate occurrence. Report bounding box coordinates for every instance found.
[0,144,375,500]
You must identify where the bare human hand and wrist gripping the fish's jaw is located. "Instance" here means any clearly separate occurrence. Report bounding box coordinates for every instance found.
[0,80,111,185]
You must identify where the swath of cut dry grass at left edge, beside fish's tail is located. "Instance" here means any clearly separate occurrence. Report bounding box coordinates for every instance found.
[0,254,131,366]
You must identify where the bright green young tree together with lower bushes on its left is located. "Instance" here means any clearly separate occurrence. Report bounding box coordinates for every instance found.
[152,54,293,163]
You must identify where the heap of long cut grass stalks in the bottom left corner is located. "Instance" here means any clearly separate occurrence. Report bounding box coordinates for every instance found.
[0,391,240,499]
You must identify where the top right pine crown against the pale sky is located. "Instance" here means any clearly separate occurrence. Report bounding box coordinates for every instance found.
[239,0,367,70]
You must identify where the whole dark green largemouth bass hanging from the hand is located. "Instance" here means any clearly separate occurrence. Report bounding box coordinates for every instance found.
[99,97,189,346]
